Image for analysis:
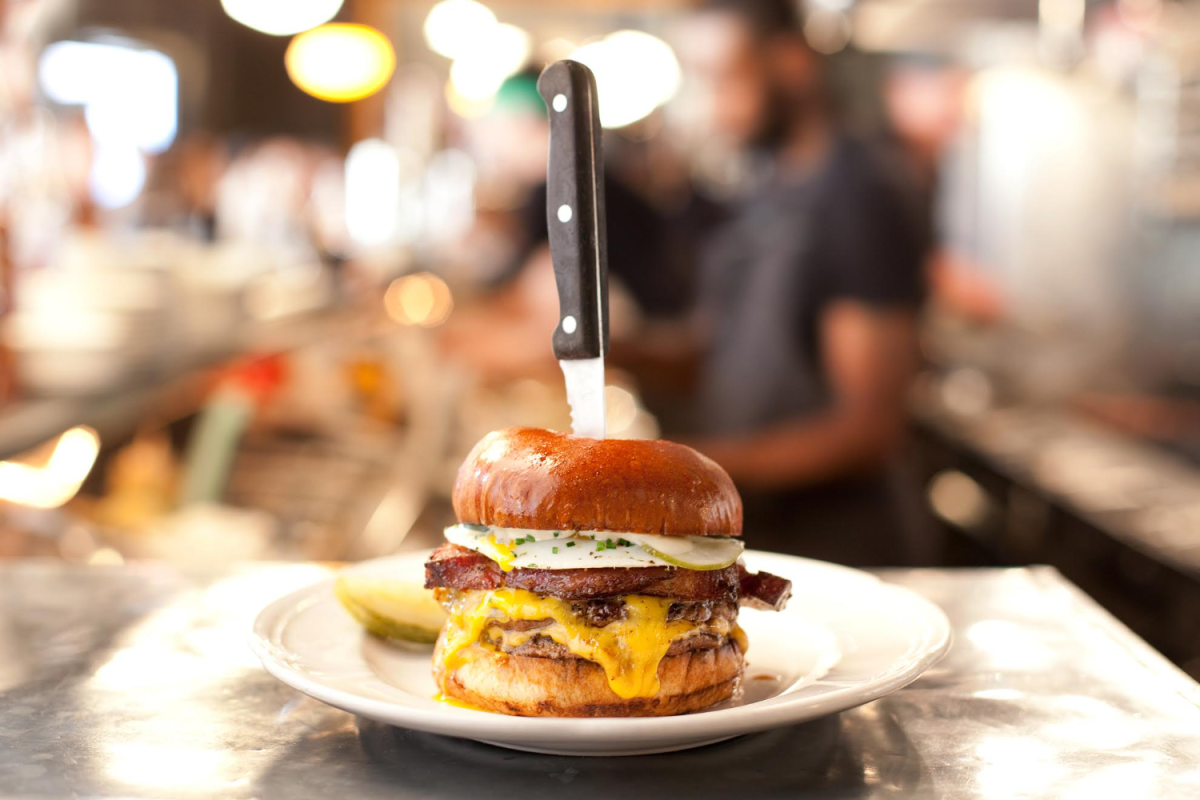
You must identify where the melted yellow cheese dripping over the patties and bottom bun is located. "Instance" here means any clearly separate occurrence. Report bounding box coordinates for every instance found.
[442,589,745,699]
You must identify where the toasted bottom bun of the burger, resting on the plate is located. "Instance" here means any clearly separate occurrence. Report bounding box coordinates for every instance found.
[433,638,744,717]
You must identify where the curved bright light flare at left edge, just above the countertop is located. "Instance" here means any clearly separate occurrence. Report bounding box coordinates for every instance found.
[0,427,100,509]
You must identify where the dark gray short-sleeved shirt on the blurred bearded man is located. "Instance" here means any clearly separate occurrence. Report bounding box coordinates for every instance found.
[696,138,929,434]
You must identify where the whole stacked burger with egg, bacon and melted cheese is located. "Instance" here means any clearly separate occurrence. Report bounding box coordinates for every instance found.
[425,428,791,717]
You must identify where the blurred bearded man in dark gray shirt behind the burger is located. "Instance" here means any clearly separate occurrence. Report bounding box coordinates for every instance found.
[642,0,929,564]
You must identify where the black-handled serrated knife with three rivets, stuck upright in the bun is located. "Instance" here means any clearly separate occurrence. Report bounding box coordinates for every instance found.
[538,61,608,439]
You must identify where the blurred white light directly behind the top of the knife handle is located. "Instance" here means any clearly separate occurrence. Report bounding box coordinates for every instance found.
[571,30,682,128]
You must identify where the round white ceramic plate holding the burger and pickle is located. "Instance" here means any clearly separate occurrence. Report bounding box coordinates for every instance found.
[250,551,950,756]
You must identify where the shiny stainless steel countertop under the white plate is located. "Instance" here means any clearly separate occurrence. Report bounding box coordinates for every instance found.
[0,563,1200,800]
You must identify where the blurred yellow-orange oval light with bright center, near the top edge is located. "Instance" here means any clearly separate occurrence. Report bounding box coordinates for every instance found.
[283,23,396,103]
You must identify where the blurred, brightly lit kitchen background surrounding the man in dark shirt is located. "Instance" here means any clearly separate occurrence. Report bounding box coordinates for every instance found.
[0,0,1200,676]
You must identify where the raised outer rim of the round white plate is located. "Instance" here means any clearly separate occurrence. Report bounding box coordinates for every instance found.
[247,551,953,752]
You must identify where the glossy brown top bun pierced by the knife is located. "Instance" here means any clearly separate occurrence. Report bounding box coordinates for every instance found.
[454,428,742,536]
